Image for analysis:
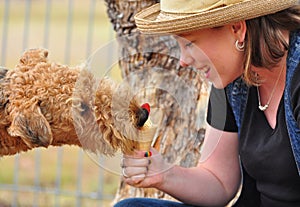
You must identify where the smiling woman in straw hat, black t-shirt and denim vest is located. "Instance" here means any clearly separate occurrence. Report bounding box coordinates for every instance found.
[116,0,300,207]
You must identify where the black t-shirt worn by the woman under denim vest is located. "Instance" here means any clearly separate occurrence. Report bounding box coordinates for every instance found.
[207,82,300,207]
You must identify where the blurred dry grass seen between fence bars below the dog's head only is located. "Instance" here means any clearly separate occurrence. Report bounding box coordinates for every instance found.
[0,147,119,206]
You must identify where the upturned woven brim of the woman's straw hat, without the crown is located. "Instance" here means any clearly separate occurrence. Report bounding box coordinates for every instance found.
[135,0,297,34]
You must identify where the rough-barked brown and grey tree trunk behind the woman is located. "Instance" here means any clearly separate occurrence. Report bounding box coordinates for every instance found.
[105,0,208,202]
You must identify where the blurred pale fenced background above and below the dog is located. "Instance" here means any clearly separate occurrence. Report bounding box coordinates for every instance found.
[0,0,119,207]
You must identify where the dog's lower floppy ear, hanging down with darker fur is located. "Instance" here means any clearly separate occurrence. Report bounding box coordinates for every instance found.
[8,104,53,148]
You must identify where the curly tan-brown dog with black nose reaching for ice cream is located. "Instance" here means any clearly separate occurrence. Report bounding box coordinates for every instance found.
[0,49,149,156]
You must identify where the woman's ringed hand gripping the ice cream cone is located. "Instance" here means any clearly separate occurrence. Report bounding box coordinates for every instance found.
[121,148,172,188]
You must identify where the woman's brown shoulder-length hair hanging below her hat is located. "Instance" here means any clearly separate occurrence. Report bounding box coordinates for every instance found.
[244,6,300,85]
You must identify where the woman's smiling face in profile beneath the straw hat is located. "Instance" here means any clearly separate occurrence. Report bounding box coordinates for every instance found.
[175,25,243,88]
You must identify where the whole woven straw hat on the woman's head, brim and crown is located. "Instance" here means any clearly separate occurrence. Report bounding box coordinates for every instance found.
[135,0,297,34]
